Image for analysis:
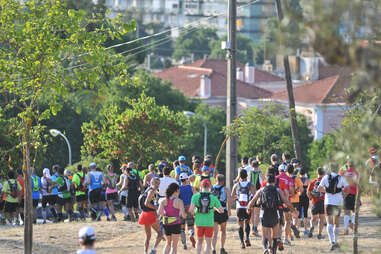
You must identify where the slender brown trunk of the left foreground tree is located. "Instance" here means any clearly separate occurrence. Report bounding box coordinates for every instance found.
[22,120,33,254]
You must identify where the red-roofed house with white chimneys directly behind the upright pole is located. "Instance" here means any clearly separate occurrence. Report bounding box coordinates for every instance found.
[154,59,284,112]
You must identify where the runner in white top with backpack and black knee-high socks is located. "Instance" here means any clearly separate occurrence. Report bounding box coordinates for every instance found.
[232,170,255,249]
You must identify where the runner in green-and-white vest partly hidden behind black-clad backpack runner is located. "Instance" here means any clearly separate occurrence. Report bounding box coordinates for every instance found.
[250,160,264,236]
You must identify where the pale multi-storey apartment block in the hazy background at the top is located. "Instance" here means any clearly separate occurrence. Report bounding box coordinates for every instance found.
[106,0,275,40]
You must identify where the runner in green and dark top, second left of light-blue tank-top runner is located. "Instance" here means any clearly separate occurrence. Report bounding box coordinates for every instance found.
[54,167,73,221]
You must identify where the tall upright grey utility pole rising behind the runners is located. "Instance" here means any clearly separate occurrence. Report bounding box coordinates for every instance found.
[225,0,237,189]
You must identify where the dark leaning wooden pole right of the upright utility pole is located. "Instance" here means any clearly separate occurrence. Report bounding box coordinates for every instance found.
[275,0,302,161]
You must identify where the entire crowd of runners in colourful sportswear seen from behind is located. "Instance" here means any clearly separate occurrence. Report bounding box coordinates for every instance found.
[0,149,374,254]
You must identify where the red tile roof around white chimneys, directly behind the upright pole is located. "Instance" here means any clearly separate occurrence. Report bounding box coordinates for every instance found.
[154,59,274,99]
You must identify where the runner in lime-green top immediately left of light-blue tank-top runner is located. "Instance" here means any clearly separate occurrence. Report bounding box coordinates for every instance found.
[73,165,88,221]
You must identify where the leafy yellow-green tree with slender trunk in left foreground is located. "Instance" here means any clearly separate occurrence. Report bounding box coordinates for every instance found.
[0,0,133,253]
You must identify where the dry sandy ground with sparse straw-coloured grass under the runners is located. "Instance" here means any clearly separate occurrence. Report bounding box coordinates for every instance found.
[0,202,381,254]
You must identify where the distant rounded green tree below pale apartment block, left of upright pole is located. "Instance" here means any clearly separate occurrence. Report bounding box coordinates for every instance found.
[172,27,218,61]
